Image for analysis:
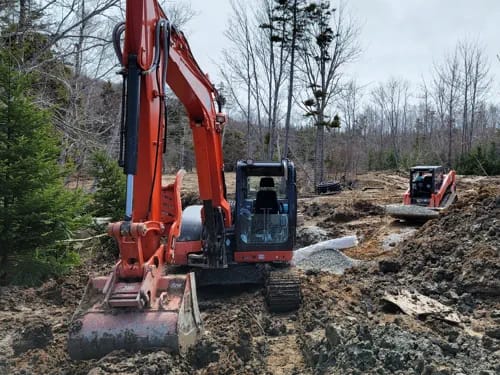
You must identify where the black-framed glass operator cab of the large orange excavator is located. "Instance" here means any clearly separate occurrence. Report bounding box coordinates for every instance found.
[235,159,297,252]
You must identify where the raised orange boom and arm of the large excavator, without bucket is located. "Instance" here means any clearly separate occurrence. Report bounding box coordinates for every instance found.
[115,0,232,268]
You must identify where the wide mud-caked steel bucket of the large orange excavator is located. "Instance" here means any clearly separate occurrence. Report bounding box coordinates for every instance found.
[68,274,202,360]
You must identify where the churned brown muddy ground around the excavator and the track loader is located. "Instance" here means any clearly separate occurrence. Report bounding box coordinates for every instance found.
[0,172,500,375]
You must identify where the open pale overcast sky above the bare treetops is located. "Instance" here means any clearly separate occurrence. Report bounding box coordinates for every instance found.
[182,0,500,98]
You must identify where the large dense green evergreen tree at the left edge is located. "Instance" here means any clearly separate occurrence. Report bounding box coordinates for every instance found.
[0,52,86,283]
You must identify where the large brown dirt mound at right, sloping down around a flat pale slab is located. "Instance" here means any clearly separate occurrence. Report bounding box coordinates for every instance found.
[299,184,500,374]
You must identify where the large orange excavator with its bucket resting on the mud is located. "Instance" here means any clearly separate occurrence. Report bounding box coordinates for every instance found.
[68,0,300,359]
